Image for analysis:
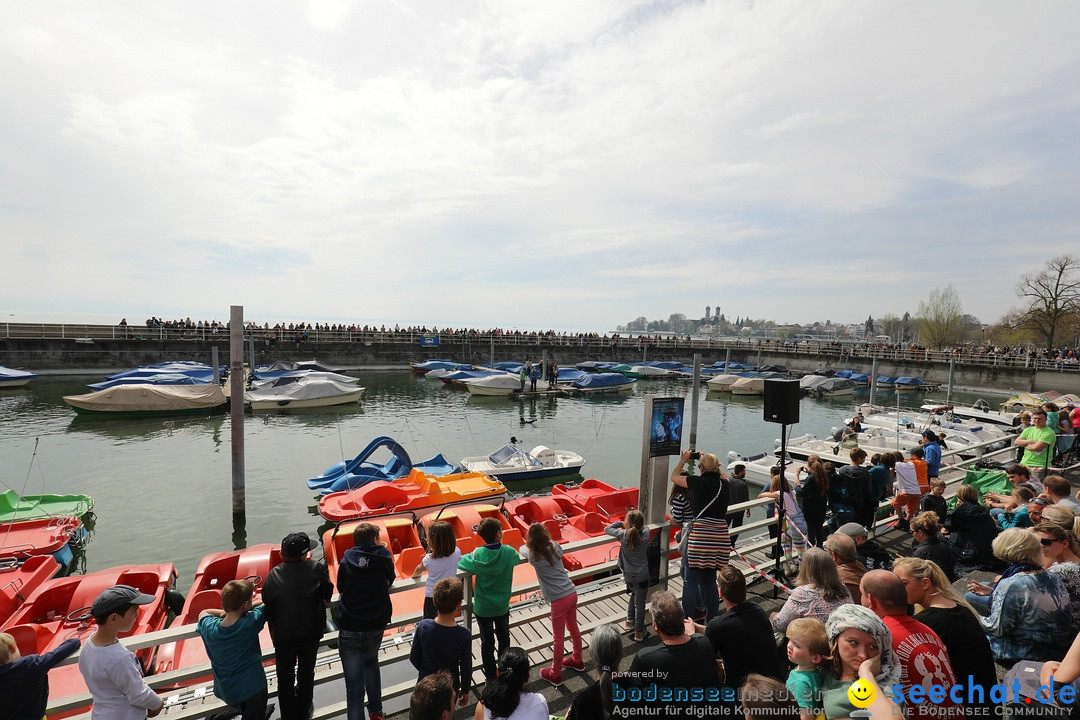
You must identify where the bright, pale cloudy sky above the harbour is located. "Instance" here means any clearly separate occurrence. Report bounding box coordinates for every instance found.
[0,0,1080,331]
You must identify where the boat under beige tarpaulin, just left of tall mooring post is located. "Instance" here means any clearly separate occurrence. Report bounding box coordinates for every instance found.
[64,383,227,418]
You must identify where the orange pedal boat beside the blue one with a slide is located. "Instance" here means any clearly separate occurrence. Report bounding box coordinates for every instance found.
[319,468,507,522]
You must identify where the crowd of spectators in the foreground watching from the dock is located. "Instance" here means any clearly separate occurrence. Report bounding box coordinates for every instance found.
[6,416,1080,720]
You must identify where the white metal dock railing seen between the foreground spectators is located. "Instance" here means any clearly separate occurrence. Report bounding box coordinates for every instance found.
[46,440,1013,720]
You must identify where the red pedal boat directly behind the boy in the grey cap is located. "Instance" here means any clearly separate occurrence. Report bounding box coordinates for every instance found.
[0,562,176,717]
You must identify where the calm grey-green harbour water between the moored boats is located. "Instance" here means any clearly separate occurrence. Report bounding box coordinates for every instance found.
[0,371,989,590]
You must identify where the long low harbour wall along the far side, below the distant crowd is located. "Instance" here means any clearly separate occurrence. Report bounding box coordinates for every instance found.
[0,334,1080,393]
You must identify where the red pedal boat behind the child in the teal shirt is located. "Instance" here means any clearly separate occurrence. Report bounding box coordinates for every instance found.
[153,543,282,688]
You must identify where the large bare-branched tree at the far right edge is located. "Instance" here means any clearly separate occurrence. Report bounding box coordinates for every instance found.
[1016,255,1080,348]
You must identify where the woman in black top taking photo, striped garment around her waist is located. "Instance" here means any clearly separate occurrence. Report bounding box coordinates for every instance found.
[672,450,731,624]
